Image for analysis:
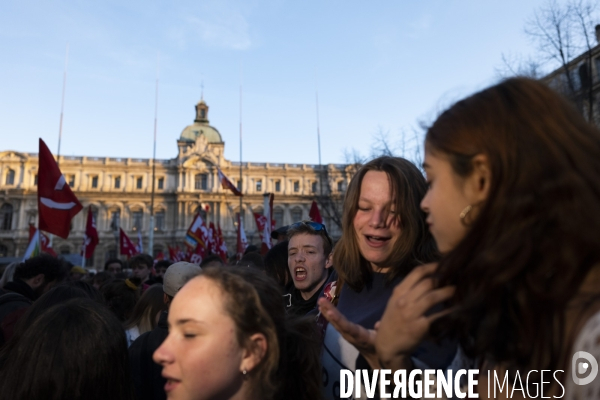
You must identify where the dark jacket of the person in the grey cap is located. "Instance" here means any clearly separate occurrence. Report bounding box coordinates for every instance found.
[129,311,169,400]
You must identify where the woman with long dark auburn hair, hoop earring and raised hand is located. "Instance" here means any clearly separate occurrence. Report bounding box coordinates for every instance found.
[377,78,600,399]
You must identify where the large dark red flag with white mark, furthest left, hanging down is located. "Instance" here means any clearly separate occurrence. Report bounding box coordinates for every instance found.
[38,139,83,239]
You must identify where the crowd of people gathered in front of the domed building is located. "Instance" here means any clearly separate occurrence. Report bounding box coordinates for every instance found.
[0,78,600,400]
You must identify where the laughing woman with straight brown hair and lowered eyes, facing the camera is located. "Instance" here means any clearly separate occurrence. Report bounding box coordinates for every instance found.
[319,157,456,398]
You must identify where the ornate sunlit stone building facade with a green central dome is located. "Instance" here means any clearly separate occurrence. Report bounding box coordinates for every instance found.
[0,100,352,268]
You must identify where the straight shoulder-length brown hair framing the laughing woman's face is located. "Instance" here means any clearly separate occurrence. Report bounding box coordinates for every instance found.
[333,157,438,291]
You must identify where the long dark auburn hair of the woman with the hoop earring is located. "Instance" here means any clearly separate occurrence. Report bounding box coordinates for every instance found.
[425,78,600,370]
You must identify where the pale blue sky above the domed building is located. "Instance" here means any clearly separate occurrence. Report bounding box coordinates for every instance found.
[0,0,576,164]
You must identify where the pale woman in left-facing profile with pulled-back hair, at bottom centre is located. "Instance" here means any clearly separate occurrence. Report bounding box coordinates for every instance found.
[154,267,322,400]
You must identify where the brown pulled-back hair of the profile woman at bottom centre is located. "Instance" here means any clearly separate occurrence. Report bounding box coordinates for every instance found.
[199,267,322,400]
